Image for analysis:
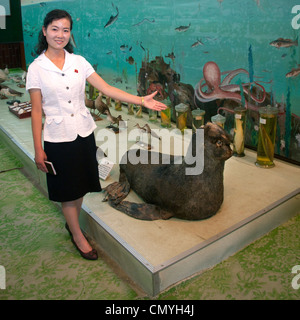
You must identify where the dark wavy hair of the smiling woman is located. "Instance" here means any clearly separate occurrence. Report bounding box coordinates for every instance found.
[35,9,74,55]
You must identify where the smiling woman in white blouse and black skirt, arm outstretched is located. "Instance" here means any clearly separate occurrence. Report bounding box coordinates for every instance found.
[26,10,166,260]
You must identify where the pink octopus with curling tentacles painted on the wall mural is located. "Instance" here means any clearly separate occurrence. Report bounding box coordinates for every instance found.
[195,61,266,113]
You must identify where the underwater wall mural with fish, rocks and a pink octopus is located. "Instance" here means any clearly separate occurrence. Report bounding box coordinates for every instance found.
[21,0,300,163]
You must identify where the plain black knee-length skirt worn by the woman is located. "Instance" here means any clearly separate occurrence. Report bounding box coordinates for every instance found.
[44,133,102,202]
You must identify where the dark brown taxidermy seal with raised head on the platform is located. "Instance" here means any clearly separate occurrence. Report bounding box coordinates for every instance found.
[103,123,232,220]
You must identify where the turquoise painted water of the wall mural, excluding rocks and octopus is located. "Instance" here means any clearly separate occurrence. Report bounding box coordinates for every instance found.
[22,0,300,161]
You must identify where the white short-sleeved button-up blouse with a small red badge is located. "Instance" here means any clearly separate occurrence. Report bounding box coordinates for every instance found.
[26,50,97,142]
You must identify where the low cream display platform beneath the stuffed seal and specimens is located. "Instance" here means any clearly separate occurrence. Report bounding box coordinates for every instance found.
[0,75,300,296]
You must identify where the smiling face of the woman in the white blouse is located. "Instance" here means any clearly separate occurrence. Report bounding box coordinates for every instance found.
[43,18,71,50]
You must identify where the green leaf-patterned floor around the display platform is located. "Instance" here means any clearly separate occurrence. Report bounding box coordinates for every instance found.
[0,141,300,300]
